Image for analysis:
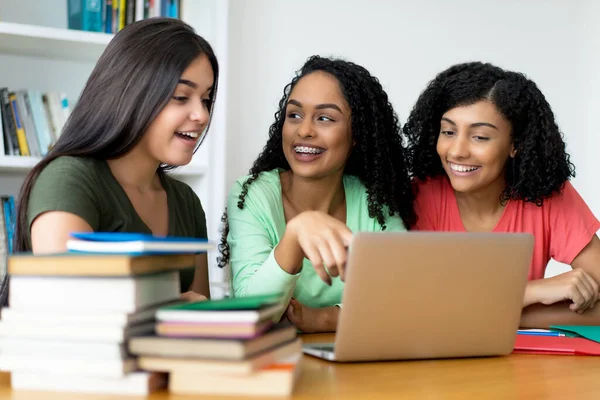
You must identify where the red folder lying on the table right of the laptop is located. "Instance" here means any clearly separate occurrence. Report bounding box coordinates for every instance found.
[513,335,600,356]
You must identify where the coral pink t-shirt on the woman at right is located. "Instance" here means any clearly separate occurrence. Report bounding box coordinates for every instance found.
[415,176,600,280]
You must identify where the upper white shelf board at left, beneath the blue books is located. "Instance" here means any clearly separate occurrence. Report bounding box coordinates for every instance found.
[0,22,114,62]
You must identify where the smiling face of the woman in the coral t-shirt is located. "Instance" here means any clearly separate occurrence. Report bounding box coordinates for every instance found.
[437,101,515,193]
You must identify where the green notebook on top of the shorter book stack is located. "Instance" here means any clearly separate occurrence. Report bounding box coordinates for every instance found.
[160,293,283,311]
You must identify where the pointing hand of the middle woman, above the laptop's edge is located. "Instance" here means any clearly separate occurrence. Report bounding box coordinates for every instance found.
[275,211,352,285]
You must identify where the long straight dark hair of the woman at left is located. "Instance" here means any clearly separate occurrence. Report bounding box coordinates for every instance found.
[14,18,219,252]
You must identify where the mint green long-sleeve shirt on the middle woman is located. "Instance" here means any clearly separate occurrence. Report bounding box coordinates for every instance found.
[227,170,406,307]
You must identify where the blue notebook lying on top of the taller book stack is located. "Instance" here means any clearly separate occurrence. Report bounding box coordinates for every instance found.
[67,232,214,254]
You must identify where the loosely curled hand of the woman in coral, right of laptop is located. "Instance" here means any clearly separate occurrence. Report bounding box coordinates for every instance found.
[525,269,599,314]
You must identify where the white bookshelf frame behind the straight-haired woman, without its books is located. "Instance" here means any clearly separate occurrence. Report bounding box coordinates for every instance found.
[0,0,229,296]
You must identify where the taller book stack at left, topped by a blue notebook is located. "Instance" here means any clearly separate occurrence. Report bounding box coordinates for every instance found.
[0,234,213,395]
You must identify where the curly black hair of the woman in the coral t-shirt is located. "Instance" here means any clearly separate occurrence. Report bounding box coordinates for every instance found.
[403,62,575,206]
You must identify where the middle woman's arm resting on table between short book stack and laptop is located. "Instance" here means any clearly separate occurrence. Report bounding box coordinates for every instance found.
[285,299,339,333]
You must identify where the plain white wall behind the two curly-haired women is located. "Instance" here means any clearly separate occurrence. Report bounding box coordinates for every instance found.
[226,0,600,273]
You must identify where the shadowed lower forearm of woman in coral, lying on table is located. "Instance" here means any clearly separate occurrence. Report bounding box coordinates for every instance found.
[520,302,600,329]
